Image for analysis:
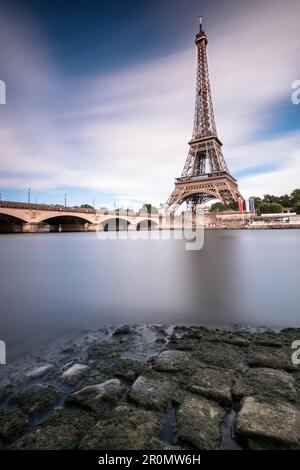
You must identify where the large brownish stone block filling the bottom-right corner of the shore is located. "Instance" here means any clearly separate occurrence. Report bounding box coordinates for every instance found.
[236,397,300,448]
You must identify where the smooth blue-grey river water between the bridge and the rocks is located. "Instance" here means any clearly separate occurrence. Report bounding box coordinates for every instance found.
[0,230,300,359]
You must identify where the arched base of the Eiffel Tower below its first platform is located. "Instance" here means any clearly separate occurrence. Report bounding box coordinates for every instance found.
[167,172,241,213]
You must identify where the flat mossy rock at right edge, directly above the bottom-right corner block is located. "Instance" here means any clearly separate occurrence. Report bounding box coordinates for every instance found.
[245,368,297,400]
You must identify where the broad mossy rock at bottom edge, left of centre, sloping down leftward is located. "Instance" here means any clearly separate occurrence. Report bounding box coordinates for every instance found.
[79,406,159,450]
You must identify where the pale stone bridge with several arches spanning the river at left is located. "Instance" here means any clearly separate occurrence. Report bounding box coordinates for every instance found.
[0,201,189,233]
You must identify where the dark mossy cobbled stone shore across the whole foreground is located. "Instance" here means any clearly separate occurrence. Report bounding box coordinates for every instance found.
[0,325,300,450]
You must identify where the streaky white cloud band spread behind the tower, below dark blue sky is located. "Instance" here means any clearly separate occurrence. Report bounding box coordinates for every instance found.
[0,0,300,207]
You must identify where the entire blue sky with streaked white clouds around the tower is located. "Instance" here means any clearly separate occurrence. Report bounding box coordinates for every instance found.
[0,0,300,208]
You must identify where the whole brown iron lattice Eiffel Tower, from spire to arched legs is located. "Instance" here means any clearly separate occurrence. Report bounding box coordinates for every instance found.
[166,16,241,214]
